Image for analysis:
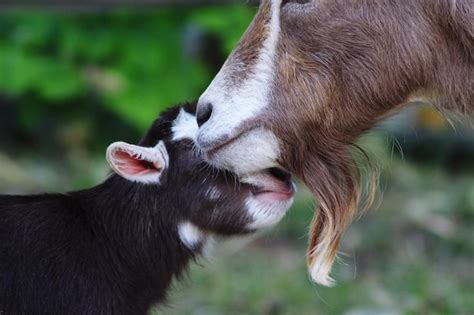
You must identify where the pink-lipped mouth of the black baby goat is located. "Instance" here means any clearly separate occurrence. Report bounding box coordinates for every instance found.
[245,167,296,202]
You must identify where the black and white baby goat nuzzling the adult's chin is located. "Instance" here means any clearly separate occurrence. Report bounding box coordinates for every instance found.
[0,104,294,315]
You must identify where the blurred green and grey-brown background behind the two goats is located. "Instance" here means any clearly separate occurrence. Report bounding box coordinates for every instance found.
[0,1,474,315]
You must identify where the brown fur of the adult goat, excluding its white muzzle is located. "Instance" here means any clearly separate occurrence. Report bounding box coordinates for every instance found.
[236,0,474,282]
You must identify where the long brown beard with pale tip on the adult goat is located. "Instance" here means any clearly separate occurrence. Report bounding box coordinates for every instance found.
[286,143,378,286]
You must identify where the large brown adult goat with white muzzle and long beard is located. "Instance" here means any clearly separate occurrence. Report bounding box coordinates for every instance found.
[197,0,474,285]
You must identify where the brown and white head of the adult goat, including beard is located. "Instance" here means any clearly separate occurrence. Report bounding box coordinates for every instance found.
[194,0,380,285]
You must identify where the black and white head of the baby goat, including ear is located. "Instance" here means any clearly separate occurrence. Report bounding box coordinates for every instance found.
[107,104,295,248]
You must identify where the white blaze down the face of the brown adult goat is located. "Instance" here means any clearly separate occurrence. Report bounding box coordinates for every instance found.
[198,0,281,144]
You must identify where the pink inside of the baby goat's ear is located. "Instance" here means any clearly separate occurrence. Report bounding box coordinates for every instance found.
[112,150,161,176]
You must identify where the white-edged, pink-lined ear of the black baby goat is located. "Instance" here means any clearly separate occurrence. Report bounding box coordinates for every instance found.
[107,141,169,184]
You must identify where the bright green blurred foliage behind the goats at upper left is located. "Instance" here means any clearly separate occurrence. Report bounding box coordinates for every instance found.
[0,6,254,131]
